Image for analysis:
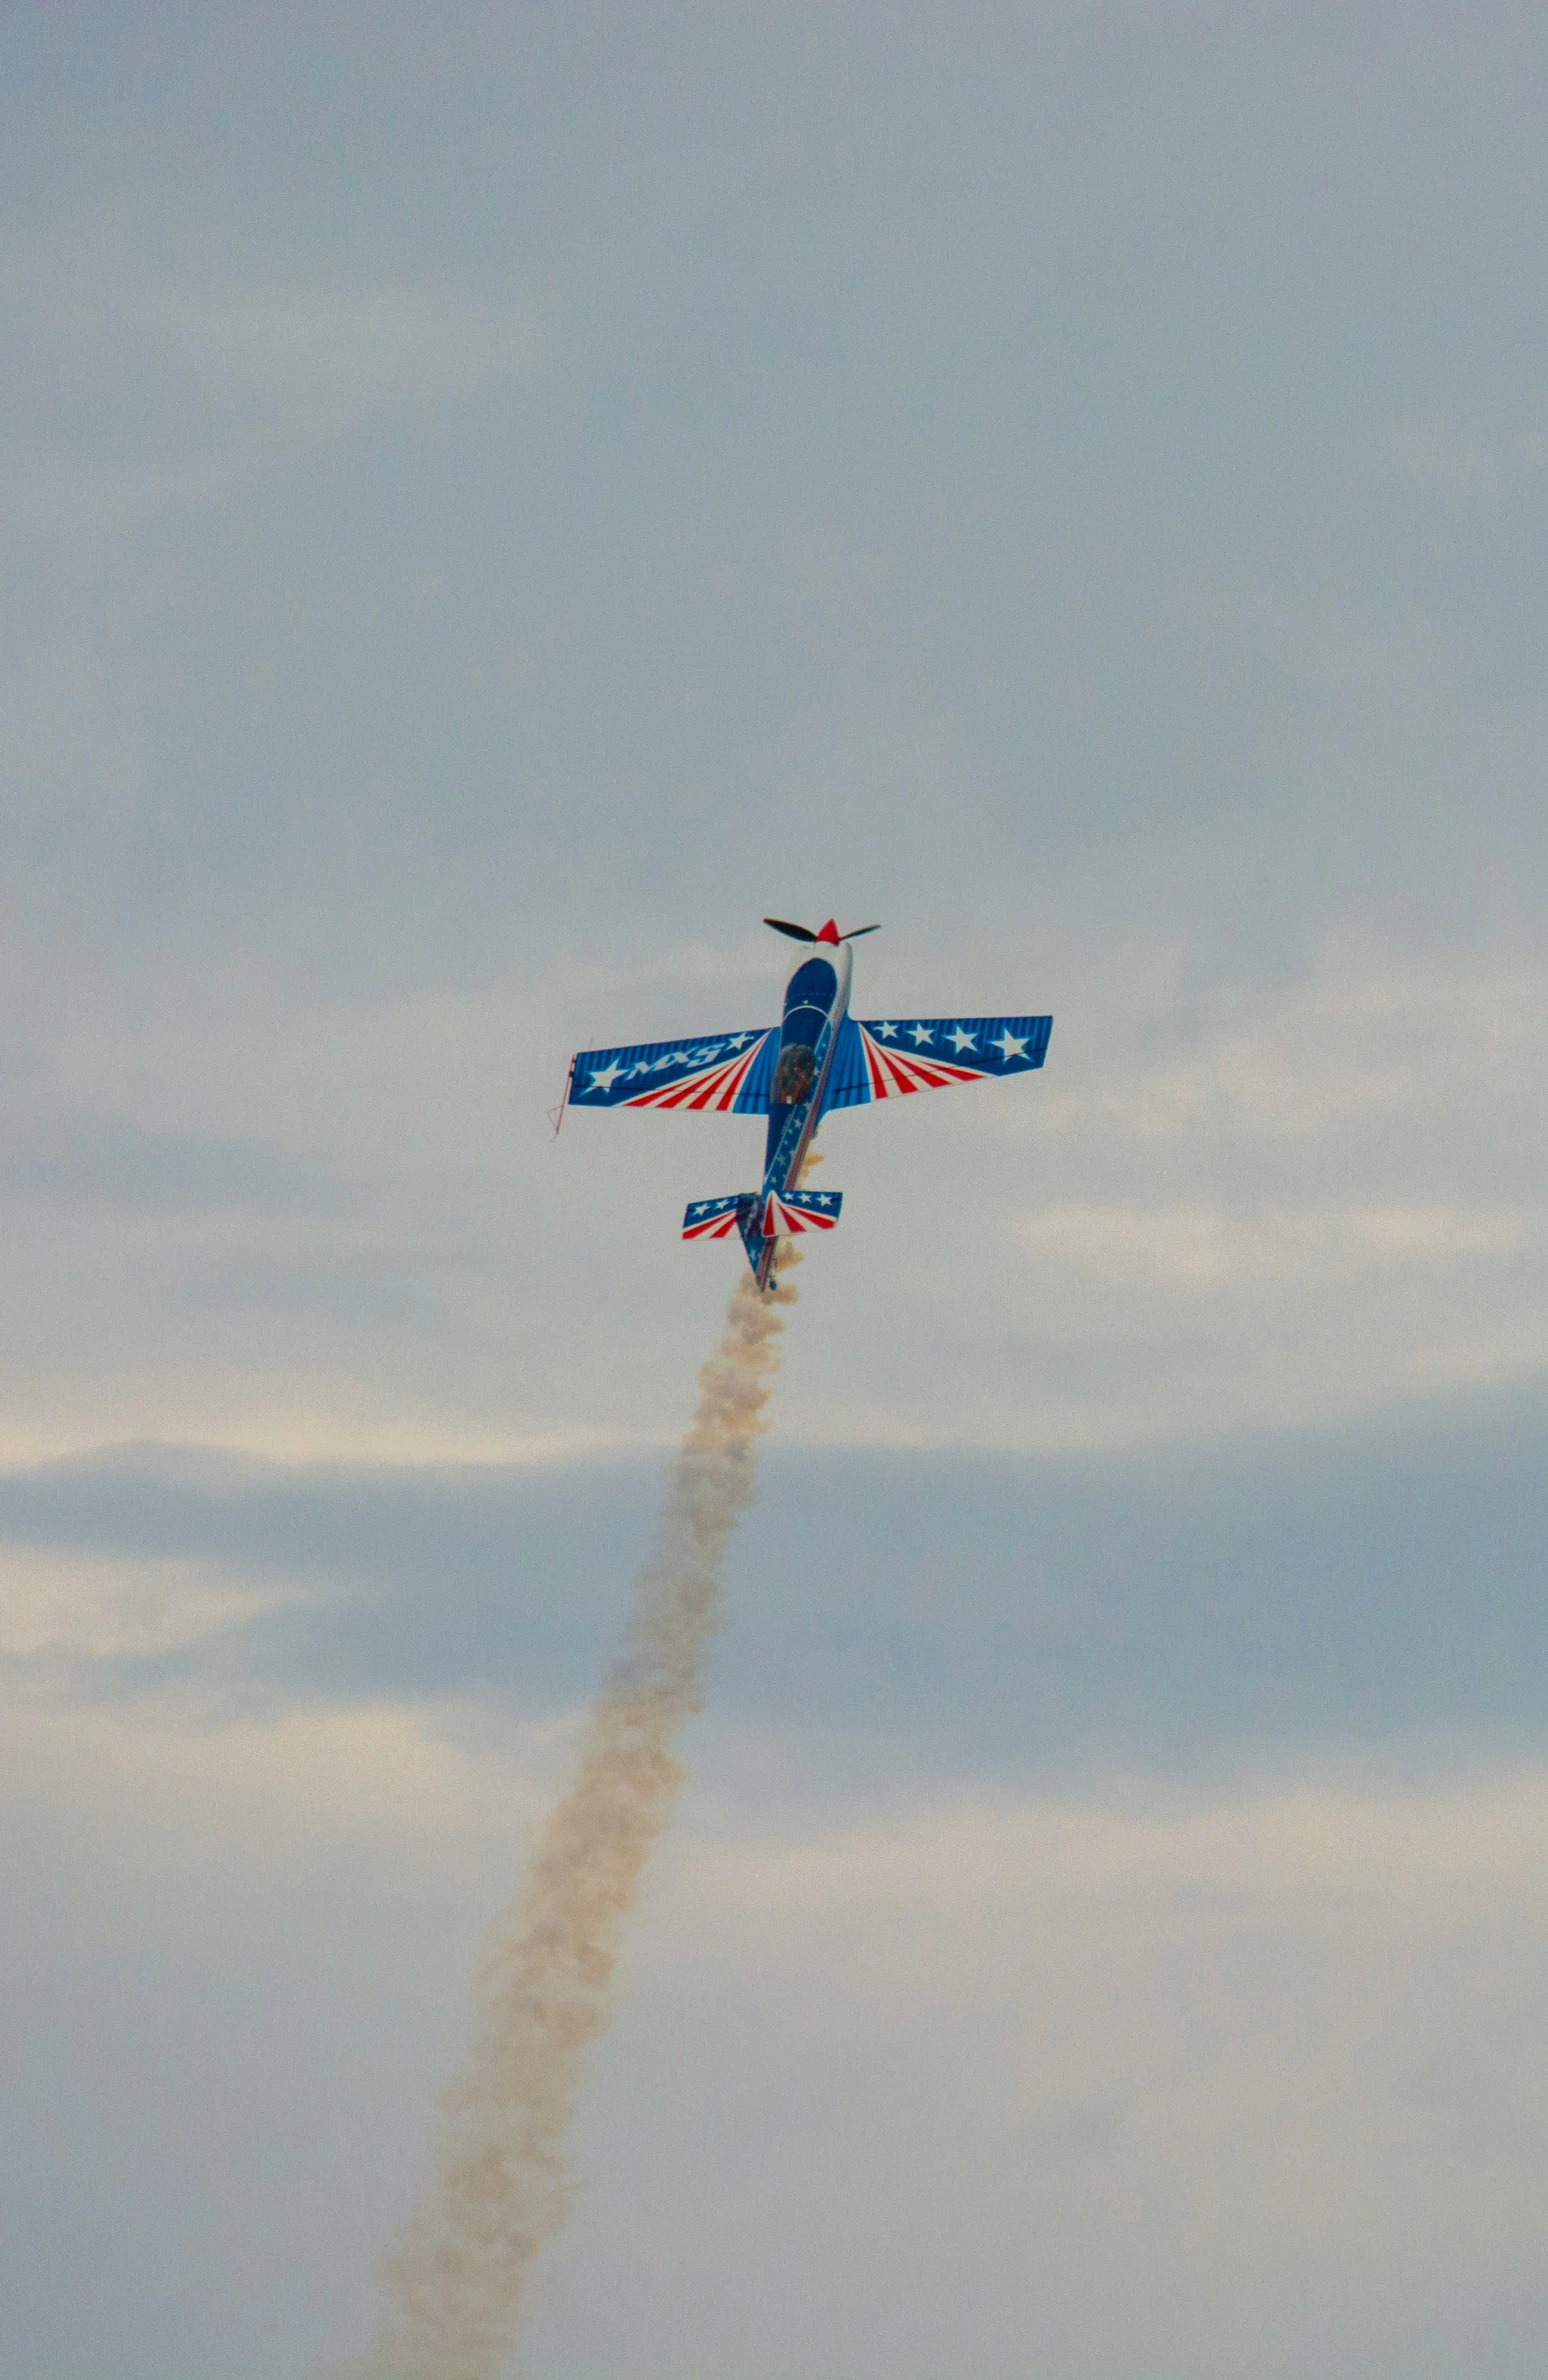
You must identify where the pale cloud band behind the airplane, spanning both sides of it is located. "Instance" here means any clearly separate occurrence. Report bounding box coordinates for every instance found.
[0,945,1548,1459]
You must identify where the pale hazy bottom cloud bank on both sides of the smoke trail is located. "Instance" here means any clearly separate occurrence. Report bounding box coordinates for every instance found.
[5,1675,1548,2380]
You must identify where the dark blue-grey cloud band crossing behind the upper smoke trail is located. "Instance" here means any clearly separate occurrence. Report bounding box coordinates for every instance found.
[0,1388,1546,1809]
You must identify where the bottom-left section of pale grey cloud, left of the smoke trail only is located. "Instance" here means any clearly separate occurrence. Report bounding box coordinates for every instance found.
[0,1685,554,2380]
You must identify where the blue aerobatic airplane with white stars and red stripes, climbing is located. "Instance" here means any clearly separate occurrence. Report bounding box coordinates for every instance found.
[555,916,1053,1290]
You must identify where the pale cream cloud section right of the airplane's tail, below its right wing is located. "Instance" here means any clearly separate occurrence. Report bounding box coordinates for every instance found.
[791,933,1548,1452]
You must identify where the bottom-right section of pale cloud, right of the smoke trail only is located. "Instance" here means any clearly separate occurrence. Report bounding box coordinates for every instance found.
[533,1768,1548,2380]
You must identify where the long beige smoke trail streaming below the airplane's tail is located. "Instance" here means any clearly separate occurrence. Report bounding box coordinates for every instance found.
[359,1245,798,2380]
